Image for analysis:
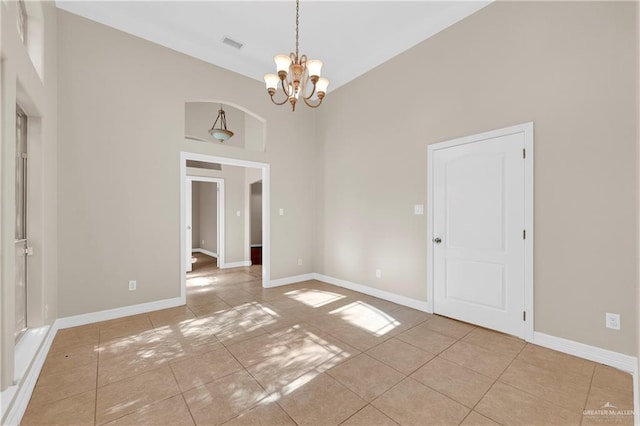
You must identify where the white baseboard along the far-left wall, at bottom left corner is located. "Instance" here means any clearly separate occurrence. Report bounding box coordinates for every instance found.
[0,324,58,426]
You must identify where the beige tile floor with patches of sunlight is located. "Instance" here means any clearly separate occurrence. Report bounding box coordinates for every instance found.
[22,255,633,425]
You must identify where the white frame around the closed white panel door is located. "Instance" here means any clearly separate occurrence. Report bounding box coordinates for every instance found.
[427,122,534,342]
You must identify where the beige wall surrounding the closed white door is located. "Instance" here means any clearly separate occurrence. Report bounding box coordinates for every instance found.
[316,2,638,355]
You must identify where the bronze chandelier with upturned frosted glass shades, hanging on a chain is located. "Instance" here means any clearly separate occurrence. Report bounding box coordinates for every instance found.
[264,0,329,111]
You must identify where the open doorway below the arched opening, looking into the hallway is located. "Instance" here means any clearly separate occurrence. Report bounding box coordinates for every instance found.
[180,152,270,300]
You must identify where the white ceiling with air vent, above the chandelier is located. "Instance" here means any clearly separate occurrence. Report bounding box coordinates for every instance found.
[56,0,492,91]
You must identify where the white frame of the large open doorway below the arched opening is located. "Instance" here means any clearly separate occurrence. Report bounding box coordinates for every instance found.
[180,152,271,300]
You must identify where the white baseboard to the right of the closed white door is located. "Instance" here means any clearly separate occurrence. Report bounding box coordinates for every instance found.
[532,331,638,374]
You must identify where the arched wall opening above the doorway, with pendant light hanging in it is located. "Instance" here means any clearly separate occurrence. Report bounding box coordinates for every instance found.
[184,102,265,151]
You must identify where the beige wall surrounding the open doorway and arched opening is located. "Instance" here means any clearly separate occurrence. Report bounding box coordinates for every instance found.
[58,11,316,317]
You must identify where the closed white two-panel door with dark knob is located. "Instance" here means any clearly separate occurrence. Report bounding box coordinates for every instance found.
[431,133,525,337]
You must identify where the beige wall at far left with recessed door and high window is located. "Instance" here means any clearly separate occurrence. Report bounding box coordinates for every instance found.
[0,2,58,396]
